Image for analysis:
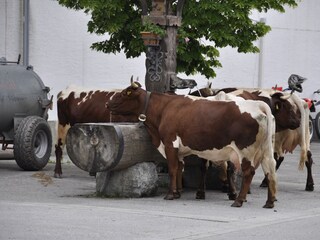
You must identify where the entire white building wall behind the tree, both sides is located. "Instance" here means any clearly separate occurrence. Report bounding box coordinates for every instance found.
[0,0,320,119]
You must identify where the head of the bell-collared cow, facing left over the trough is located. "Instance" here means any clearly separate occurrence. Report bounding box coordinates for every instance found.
[107,82,146,117]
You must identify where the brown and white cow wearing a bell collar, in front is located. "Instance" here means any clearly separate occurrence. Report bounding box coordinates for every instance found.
[108,83,277,208]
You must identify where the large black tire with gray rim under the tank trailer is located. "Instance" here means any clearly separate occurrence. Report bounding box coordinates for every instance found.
[13,116,52,171]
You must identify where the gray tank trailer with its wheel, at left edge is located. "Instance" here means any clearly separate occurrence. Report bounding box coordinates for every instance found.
[0,57,52,171]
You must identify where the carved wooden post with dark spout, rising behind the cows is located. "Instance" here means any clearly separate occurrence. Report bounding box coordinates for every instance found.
[141,0,197,93]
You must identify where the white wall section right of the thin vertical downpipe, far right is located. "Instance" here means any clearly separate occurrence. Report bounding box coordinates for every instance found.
[263,0,320,97]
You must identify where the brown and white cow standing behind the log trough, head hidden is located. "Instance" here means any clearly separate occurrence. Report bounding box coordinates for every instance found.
[54,86,138,177]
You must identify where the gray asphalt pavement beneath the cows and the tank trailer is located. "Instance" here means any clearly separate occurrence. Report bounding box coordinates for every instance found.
[0,143,320,240]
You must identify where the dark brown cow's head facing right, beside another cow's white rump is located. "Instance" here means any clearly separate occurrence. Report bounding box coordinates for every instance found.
[270,92,301,132]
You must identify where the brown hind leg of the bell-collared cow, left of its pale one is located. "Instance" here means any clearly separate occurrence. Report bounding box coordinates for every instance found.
[231,158,255,207]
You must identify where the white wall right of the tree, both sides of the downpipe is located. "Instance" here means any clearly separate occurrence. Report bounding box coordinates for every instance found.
[213,0,320,99]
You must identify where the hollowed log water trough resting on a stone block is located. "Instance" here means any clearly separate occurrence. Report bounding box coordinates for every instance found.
[66,123,165,172]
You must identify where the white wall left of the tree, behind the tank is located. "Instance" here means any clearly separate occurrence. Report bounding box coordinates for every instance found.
[0,0,145,120]
